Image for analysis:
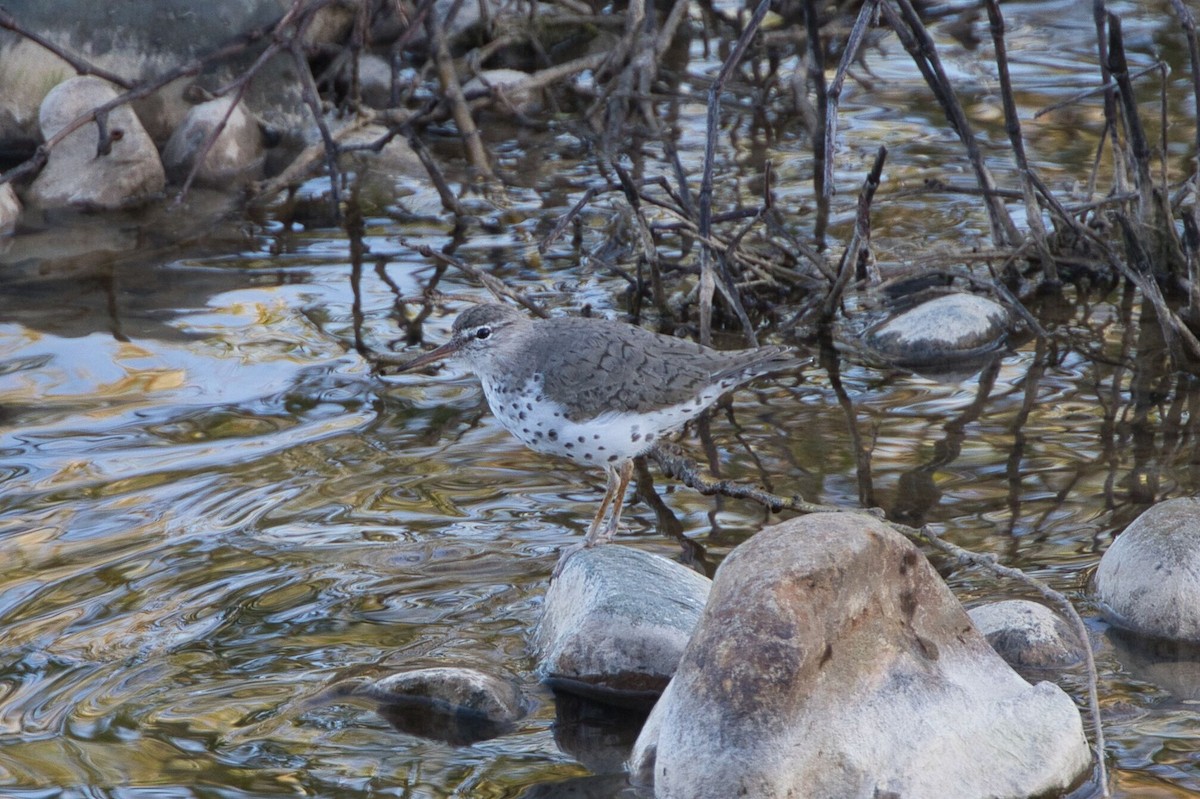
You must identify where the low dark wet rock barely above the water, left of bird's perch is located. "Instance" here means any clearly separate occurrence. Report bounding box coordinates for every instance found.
[342,667,527,745]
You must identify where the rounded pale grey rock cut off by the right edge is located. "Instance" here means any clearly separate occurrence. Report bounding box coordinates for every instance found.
[1094,497,1200,643]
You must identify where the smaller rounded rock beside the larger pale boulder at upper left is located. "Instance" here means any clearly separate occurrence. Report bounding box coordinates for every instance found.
[162,97,264,187]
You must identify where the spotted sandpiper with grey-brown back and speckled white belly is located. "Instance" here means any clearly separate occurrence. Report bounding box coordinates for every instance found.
[401,305,799,557]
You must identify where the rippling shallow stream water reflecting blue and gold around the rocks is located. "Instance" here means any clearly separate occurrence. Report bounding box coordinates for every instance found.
[0,2,1200,798]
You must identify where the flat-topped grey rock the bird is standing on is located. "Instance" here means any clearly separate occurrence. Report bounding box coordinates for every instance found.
[534,545,710,707]
